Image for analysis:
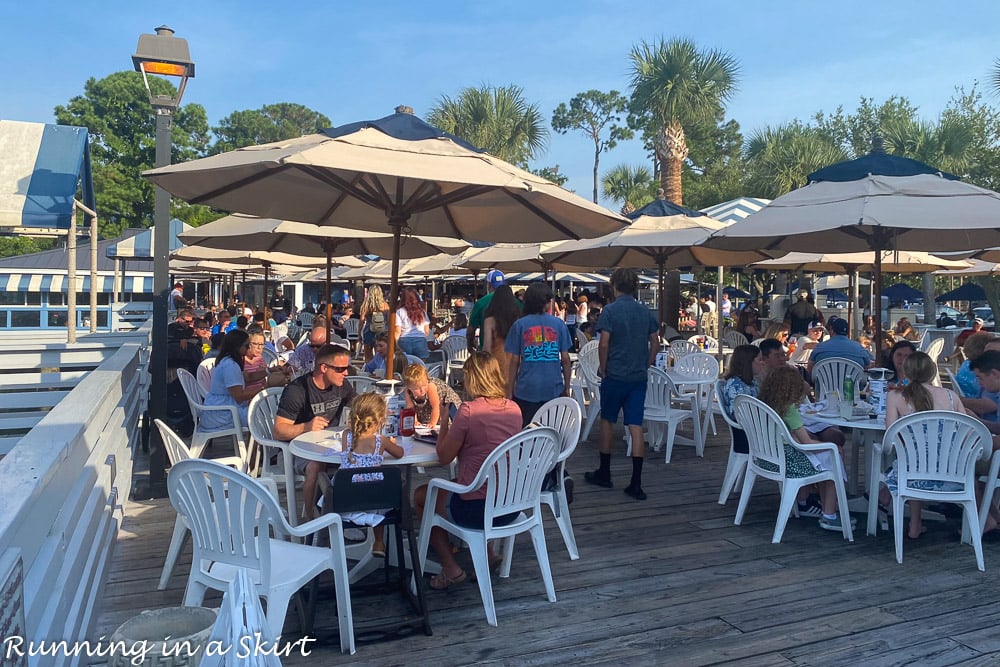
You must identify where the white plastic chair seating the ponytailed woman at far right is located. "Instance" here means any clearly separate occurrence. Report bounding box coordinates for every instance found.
[868,410,1000,571]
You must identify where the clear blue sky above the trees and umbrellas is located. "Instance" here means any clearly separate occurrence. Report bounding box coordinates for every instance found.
[0,0,1000,209]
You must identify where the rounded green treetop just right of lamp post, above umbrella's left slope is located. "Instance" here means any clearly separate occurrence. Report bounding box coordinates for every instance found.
[209,102,333,155]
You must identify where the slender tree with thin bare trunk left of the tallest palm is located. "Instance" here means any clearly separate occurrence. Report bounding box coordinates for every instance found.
[552,90,633,204]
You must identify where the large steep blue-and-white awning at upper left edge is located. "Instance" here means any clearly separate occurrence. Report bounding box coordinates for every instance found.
[0,120,96,231]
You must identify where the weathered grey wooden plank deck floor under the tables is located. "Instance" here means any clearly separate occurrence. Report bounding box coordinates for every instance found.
[97,420,1000,667]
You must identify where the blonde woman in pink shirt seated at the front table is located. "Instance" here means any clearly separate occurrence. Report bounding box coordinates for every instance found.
[414,352,521,590]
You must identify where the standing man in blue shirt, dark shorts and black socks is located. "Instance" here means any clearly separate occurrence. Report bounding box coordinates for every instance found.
[584,269,660,500]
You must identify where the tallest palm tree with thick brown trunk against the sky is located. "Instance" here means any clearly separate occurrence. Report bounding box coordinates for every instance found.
[630,39,740,204]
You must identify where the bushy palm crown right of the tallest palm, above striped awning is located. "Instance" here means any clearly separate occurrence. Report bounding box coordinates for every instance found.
[744,121,848,199]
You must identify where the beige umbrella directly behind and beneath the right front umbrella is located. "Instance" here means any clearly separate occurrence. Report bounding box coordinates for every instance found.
[751,250,969,335]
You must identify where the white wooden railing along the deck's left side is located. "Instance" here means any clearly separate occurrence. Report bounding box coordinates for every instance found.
[0,323,150,665]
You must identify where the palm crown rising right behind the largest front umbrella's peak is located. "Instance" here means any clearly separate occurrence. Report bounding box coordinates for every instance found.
[427,85,548,168]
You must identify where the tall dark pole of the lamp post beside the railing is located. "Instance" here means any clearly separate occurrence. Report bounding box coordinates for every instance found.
[146,108,173,498]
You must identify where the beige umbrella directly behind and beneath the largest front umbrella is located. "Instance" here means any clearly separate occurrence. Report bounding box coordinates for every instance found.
[178,213,469,321]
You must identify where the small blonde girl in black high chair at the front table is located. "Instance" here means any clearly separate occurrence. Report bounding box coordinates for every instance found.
[340,393,405,558]
